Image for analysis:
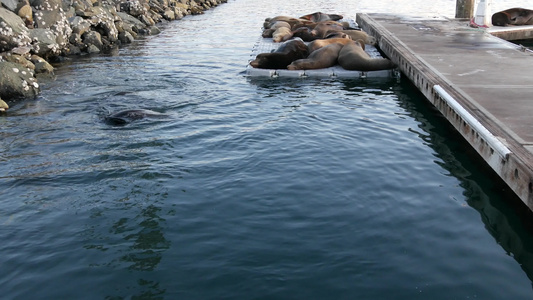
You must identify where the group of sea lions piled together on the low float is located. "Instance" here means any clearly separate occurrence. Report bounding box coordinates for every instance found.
[250,12,395,71]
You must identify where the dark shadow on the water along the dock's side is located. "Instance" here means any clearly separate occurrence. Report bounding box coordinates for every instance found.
[366,78,533,281]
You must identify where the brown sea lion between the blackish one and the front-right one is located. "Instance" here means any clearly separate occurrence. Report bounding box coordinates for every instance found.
[287,43,344,70]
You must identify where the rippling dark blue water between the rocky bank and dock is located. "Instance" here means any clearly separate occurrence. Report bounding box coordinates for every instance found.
[0,0,533,299]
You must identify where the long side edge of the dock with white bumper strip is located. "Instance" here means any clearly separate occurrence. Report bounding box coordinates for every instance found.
[356,14,533,211]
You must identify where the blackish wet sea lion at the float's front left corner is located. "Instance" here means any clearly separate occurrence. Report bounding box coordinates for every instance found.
[250,39,309,69]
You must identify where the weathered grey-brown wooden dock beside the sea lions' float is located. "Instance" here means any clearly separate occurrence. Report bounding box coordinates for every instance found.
[357,14,533,210]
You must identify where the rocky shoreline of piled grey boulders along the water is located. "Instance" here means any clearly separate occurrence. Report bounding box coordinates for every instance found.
[0,0,227,111]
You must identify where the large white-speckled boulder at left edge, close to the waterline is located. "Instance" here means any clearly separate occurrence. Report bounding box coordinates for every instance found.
[0,61,39,99]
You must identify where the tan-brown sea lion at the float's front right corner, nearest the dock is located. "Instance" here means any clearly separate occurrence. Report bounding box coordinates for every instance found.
[338,40,395,71]
